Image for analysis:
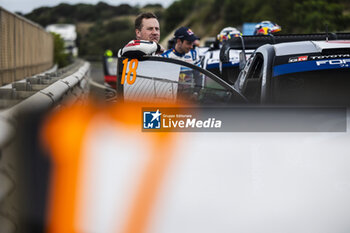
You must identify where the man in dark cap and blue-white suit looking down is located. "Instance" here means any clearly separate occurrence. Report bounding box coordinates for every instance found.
[162,27,200,66]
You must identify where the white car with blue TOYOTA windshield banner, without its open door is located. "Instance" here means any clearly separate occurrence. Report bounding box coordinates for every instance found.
[234,38,350,106]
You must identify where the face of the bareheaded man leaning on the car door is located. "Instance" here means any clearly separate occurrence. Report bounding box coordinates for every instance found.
[135,18,160,43]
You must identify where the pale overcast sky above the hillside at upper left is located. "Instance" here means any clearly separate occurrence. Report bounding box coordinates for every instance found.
[0,0,174,14]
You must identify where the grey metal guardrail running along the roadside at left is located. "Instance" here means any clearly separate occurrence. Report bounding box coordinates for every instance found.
[0,61,90,150]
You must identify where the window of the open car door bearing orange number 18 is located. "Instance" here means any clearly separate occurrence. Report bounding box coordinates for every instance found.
[118,57,244,104]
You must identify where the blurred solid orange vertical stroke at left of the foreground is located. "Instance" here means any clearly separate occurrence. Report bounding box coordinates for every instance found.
[43,103,94,233]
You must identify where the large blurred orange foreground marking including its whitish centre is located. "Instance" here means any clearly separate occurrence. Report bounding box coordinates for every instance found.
[42,103,180,233]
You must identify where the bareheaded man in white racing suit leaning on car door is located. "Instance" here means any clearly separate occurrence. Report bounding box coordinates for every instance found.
[118,12,164,58]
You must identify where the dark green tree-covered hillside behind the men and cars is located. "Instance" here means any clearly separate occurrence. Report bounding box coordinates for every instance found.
[24,0,350,60]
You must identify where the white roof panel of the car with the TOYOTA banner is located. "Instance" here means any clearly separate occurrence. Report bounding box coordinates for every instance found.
[273,40,350,56]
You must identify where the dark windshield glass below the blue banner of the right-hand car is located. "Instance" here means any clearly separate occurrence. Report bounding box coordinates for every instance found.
[273,68,350,106]
